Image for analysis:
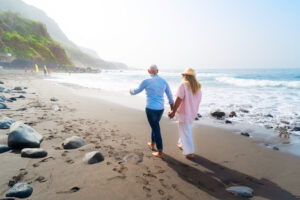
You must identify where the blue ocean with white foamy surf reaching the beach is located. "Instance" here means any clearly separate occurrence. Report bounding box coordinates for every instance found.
[48,69,300,155]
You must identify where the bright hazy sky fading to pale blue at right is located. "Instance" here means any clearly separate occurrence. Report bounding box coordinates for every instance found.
[25,0,300,68]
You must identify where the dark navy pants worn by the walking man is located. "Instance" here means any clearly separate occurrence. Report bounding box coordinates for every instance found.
[146,108,164,151]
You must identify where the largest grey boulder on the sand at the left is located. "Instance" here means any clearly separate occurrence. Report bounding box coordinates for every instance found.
[8,122,43,149]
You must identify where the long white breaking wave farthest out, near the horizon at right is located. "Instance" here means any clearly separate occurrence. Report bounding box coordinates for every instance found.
[216,77,300,89]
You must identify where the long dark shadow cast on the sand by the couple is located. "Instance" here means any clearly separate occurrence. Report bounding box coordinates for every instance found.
[164,154,300,200]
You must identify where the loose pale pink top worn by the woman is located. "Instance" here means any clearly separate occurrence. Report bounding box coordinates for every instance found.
[175,83,202,123]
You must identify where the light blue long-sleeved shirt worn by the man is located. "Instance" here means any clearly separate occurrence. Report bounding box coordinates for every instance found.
[131,74,174,110]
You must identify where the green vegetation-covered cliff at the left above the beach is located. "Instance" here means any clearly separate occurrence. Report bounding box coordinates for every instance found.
[0,12,72,65]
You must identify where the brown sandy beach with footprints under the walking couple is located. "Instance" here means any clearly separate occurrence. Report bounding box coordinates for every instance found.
[0,70,300,200]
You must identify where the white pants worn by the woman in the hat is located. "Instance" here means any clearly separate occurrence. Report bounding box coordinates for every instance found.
[178,122,194,155]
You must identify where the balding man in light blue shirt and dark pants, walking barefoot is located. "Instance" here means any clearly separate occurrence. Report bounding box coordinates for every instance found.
[129,65,174,158]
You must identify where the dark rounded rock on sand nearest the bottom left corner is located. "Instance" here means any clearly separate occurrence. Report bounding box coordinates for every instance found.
[6,183,33,198]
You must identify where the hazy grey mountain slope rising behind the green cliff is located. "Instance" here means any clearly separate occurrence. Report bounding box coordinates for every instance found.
[0,0,127,69]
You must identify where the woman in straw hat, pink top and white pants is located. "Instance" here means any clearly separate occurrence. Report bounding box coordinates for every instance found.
[168,68,202,158]
